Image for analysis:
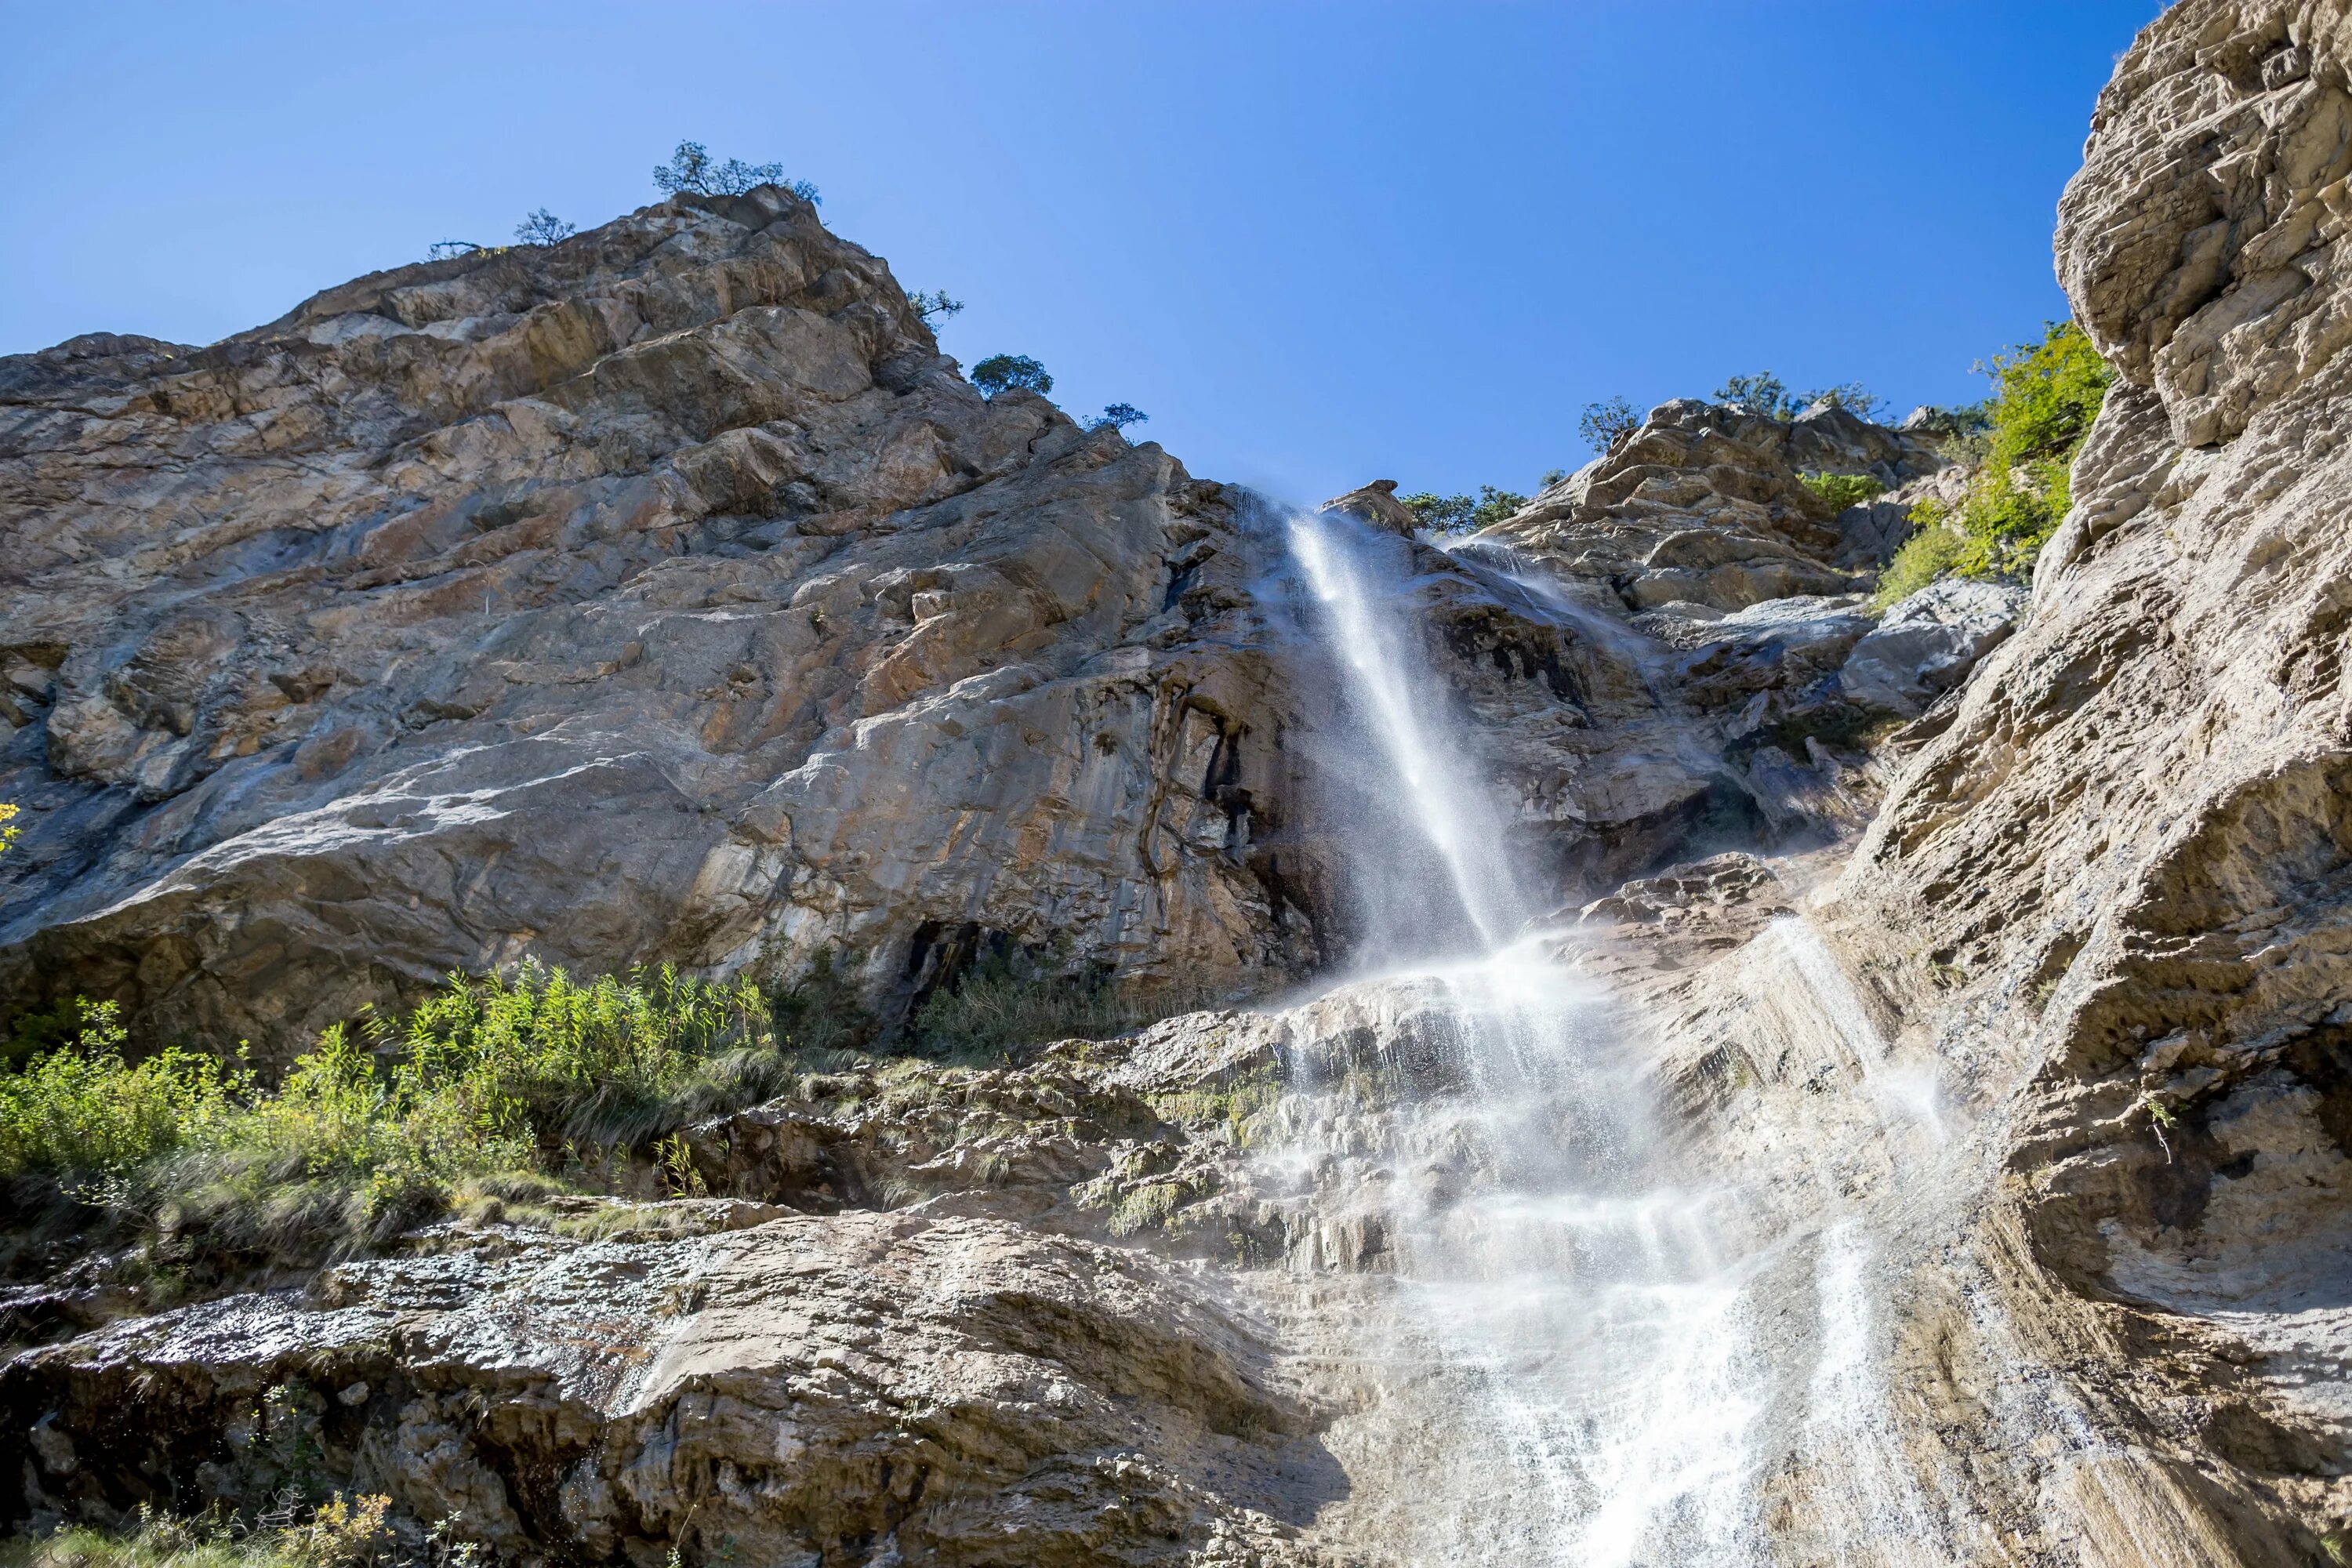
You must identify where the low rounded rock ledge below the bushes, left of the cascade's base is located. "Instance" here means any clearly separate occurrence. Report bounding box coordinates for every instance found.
[0,1213,1334,1566]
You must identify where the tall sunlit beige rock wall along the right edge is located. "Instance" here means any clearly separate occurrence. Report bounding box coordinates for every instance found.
[1839,0,2352,1563]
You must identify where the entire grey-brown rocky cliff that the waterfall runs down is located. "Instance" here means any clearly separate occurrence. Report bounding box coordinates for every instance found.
[13,0,2352,1568]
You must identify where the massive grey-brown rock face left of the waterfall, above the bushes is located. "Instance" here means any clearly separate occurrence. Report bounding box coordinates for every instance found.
[0,188,1315,1048]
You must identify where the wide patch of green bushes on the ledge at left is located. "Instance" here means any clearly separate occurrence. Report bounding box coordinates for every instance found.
[0,964,795,1250]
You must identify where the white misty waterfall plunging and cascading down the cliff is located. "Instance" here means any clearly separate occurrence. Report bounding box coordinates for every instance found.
[1261,515,1943,1568]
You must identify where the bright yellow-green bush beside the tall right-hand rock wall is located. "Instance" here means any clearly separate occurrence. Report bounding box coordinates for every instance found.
[1879,322,2114,604]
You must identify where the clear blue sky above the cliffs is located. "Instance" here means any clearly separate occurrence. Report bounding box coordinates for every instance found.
[0,0,2159,499]
